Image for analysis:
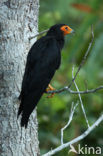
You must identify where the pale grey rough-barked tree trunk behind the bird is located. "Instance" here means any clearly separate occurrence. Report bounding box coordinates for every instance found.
[0,0,39,156]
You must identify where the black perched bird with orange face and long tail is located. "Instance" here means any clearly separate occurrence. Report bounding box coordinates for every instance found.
[18,24,73,128]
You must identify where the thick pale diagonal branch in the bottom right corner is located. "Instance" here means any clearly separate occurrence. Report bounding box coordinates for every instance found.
[42,114,103,156]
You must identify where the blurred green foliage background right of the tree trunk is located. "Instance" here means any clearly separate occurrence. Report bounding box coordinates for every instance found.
[38,0,103,156]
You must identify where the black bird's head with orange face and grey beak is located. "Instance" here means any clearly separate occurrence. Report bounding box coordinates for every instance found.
[47,24,74,38]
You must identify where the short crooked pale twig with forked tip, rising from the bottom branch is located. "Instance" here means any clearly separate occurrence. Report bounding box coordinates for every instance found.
[61,102,78,145]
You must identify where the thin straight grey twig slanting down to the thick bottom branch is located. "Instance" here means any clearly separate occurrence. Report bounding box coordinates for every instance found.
[72,67,90,128]
